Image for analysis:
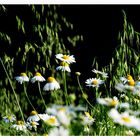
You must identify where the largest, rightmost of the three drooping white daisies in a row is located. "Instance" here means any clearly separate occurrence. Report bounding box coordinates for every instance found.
[43,77,60,91]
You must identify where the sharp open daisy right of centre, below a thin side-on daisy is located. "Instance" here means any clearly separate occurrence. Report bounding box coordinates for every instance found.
[85,78,104,87]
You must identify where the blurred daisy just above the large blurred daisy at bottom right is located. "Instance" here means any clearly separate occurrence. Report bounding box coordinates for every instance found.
[97,96,119,107]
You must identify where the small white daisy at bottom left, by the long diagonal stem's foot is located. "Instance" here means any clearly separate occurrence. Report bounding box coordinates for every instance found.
[11,121,27,131]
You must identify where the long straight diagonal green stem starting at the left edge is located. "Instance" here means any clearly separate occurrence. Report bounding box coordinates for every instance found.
[0,58,25,123]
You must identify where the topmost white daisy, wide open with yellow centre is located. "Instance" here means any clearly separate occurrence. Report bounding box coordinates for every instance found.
[55,54,76,64]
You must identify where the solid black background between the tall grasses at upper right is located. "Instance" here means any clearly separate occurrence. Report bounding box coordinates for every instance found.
[62,5,140,76]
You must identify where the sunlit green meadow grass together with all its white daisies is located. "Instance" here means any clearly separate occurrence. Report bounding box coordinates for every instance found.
[0,6,140,136]
